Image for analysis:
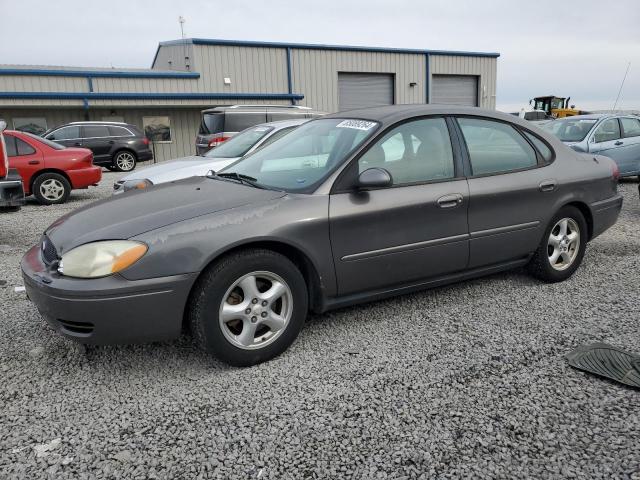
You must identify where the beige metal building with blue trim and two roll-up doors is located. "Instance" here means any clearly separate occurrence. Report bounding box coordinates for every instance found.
[0,38,499,161]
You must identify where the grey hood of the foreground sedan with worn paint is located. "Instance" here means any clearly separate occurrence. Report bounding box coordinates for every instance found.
[45,177,285,254]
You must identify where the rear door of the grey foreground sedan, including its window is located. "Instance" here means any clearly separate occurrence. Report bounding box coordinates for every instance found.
[457,117,559,268]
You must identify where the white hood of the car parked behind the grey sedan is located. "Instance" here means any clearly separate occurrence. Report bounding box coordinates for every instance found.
[120,156,238,185]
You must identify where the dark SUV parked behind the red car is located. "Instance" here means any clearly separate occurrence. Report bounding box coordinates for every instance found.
[44,122,153,172]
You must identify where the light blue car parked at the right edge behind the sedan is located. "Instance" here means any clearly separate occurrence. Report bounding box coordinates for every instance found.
[542,113,640,177]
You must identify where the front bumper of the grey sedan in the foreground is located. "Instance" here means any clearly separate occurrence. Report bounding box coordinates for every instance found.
[21,246,197,345]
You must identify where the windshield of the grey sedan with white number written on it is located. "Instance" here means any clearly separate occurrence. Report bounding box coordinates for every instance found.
[222,118,378,193]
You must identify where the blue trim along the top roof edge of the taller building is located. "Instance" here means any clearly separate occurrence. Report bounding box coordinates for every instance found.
[160,38,500,58]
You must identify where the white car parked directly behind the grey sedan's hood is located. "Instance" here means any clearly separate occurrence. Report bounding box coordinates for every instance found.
[113,118,309,195]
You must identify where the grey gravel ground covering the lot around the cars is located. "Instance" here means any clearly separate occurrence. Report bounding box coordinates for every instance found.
[0,173,640,479]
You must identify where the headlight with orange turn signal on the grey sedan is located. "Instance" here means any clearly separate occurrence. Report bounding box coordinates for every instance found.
[58,240,147,278]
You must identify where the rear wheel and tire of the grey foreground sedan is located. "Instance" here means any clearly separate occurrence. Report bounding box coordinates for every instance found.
[528,206,588,283]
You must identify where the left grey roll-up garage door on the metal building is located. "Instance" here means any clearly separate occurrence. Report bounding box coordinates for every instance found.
[338,73,394,111]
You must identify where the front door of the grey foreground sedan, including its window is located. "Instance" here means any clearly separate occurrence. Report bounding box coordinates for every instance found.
[329,118,469,295]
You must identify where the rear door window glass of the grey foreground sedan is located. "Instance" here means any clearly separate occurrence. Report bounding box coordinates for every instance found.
[458,118,538,175]
